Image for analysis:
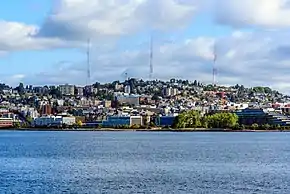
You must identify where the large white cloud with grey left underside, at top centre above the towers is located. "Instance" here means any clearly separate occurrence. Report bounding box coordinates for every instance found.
[39,0,198,39]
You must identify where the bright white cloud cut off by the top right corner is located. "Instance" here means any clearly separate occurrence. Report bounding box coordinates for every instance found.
[214,0,290,28]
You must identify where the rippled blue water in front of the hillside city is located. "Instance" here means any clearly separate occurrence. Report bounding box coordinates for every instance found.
[0,131,290,194]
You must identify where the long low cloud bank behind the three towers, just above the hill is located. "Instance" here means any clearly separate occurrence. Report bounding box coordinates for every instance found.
[1,31,290,93]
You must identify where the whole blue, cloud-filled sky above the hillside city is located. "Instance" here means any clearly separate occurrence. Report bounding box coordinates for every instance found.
[0,0,290,93]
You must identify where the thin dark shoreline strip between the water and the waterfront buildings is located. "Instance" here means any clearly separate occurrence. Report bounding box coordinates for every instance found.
[0,128,290,133]
